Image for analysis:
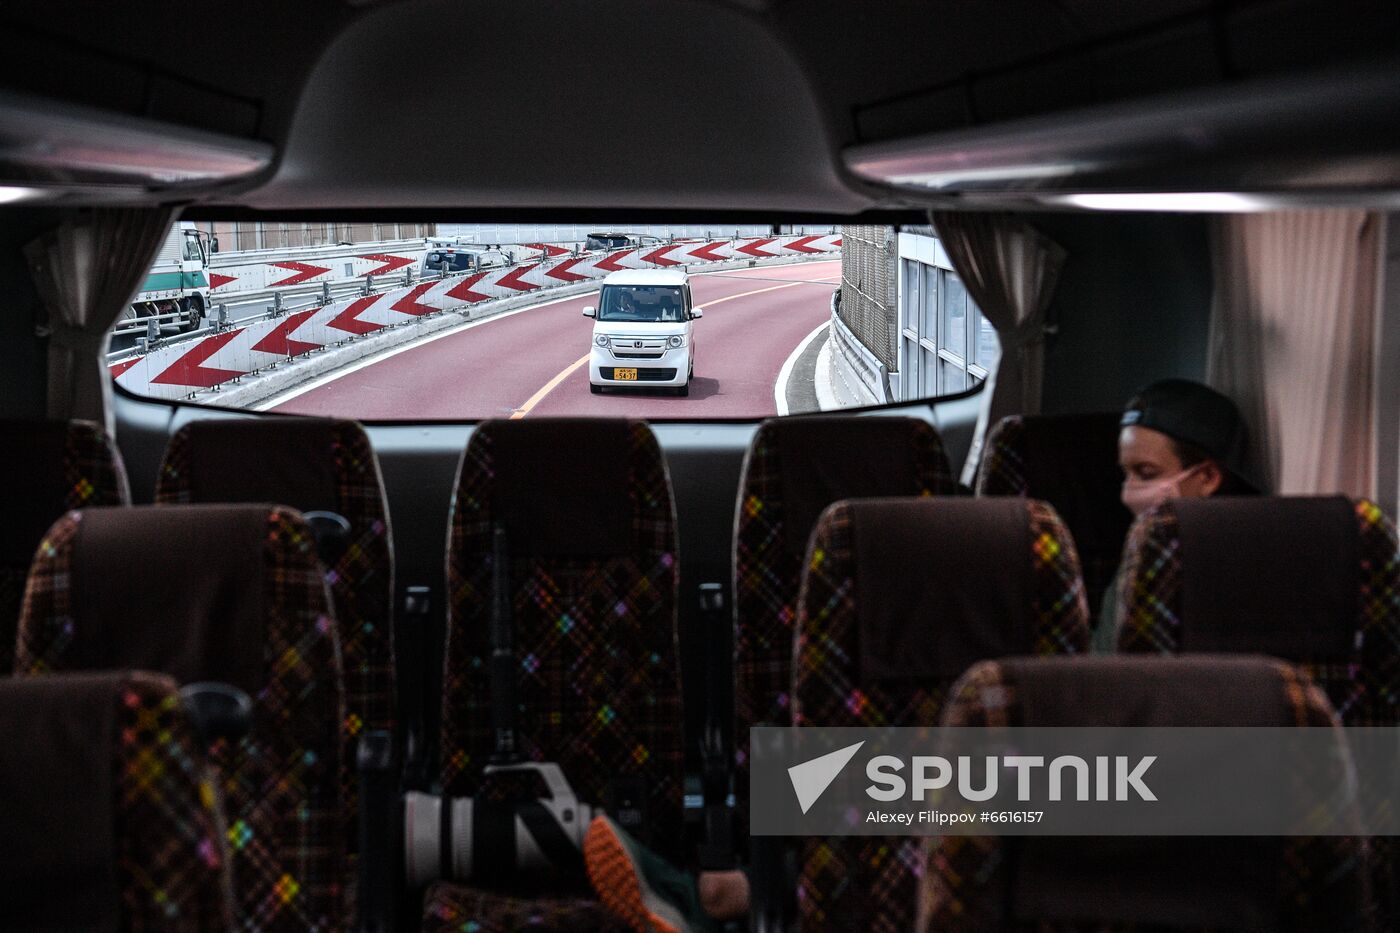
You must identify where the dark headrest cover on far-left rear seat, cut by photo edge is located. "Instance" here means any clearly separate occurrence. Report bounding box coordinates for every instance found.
[0,420,78,566]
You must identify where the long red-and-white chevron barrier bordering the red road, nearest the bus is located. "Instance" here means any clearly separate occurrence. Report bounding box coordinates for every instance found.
[111,234,841,399]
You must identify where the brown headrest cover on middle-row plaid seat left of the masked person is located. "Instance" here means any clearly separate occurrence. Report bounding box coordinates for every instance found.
[822,496,1036,682]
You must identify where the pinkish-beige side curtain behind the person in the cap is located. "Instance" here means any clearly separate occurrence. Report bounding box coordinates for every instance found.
[1207,210,1385,496]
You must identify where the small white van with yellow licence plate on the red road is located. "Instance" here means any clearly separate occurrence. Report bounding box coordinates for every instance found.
[584,269,701,395]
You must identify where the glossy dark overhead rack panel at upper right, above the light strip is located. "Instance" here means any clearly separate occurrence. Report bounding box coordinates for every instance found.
[844,62,1400,209]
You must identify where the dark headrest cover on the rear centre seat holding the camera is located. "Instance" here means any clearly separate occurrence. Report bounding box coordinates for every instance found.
[476,417,641,559]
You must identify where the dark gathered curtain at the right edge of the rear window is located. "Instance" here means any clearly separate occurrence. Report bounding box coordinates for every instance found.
[930,212,1065,485]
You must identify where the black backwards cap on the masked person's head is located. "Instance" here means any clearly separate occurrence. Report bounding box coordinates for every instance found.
[1119,380,1259,492]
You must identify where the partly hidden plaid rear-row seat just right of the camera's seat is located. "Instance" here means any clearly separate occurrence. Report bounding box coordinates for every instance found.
[734,416,958,835]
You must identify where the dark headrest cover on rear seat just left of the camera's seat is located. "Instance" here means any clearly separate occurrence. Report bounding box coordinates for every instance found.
[181,417,343,511]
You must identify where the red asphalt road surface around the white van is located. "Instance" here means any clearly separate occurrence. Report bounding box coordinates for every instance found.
[273,261,841,420]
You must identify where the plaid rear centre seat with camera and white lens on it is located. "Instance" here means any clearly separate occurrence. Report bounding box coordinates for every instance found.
[424,419,683,933]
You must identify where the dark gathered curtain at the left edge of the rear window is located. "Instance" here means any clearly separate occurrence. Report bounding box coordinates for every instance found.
[24,207,174,427]
